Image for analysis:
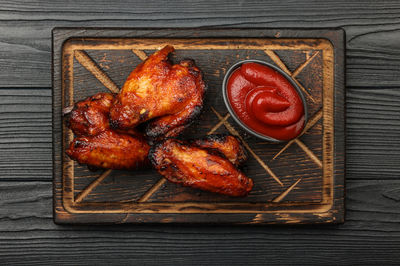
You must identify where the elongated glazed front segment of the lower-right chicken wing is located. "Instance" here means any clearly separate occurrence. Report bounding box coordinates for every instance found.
[149,139,253,196]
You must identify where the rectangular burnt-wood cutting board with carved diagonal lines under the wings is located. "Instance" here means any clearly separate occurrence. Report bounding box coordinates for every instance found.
[53,28,345,224]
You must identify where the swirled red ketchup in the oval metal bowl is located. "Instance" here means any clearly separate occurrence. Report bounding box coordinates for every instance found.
[227,63,304,140]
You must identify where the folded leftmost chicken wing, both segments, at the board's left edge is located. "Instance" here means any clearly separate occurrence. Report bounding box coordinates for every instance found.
[66,93,150,169]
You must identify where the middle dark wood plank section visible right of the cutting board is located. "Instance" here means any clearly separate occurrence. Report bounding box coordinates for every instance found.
[346,88,400,179]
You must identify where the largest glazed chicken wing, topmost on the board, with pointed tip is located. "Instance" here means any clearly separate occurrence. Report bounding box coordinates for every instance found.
[110,45,206,139]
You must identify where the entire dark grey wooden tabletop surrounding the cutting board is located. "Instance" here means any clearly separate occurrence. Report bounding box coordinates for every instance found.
[0,0,400,265]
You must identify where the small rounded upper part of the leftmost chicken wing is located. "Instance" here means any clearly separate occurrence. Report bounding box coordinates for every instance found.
[67,93,114,136]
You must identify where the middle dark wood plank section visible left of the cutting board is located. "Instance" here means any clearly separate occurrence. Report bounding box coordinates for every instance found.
[0,89,52,180]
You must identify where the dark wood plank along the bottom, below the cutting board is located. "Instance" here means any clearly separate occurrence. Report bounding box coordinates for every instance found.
[0,180,400,265]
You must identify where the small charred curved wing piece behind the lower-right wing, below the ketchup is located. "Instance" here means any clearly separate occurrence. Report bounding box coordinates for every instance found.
[191,134,247,166]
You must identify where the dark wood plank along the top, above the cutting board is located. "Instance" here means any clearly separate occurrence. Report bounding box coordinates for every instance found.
[0,0,400,87]
